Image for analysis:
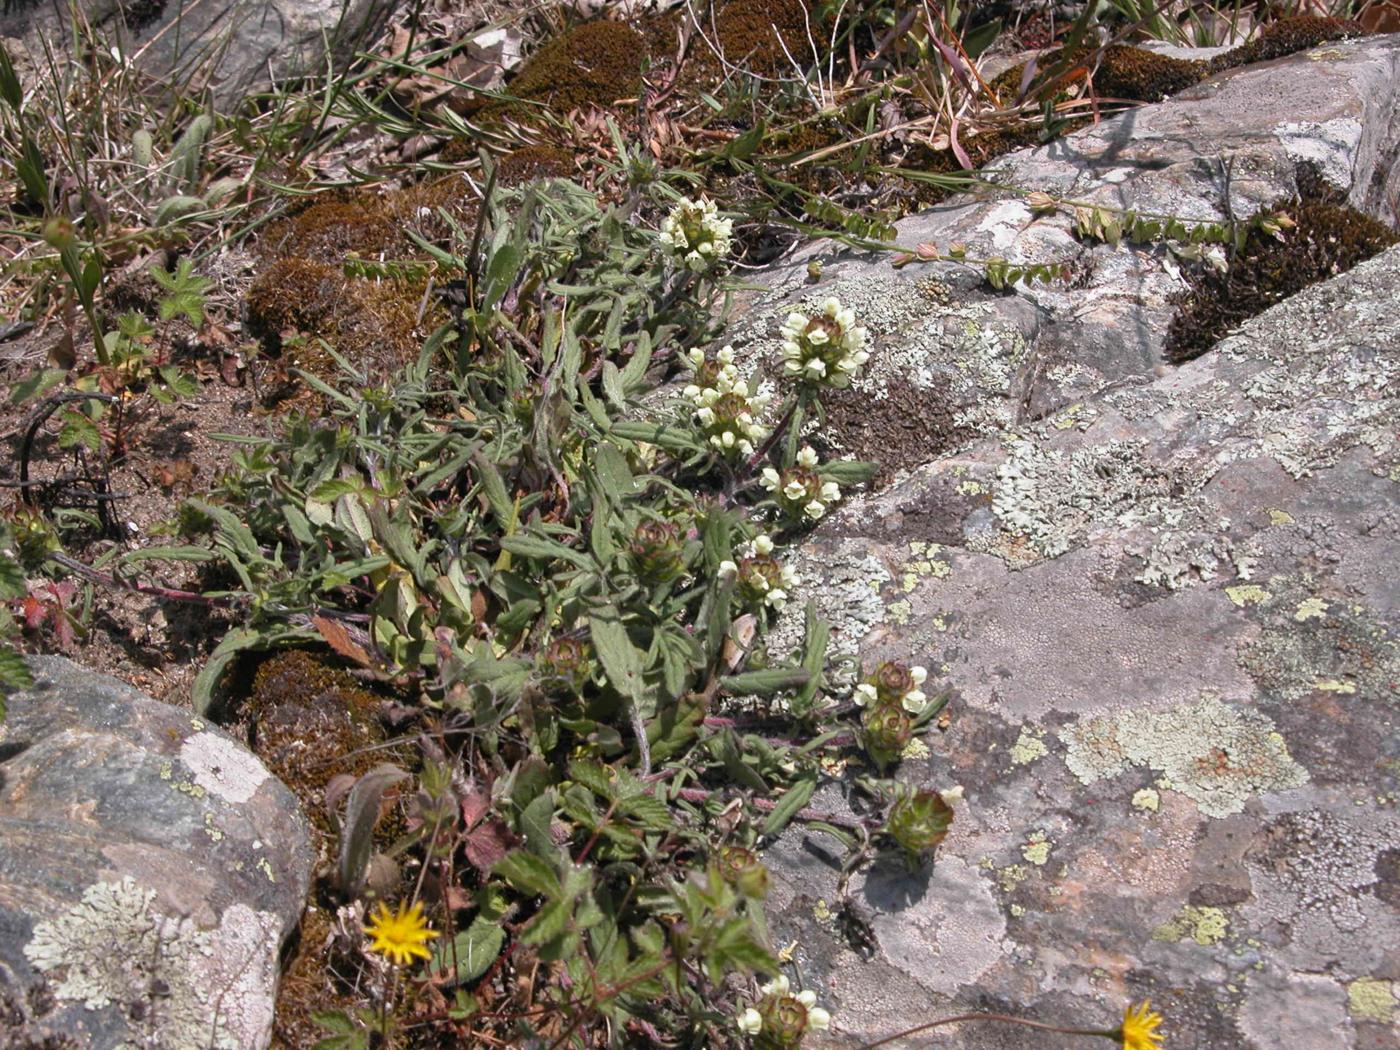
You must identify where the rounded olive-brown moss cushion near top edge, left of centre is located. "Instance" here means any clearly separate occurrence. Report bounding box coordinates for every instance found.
[498,21,645,113]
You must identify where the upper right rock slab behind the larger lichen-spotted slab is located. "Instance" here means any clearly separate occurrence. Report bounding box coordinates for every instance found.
[729,36,1400,469]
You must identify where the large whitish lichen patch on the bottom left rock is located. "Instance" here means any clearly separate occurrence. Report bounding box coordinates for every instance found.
[24,876,238,1050]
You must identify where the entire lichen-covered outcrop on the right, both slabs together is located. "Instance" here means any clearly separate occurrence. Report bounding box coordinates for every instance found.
[735,38,1400,1050]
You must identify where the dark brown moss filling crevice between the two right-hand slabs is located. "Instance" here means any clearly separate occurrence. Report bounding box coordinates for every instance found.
[1162,177,1400,364]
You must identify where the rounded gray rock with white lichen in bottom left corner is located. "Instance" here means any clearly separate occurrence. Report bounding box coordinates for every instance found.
[0,657,312,1050]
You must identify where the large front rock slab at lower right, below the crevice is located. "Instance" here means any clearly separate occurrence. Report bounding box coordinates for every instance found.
[767,233,1400,1050]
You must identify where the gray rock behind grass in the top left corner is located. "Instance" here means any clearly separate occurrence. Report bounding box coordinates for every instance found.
[0,0,395,108]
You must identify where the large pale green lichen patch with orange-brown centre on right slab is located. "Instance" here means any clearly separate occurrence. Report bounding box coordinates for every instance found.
[1061,696,1308,816]
